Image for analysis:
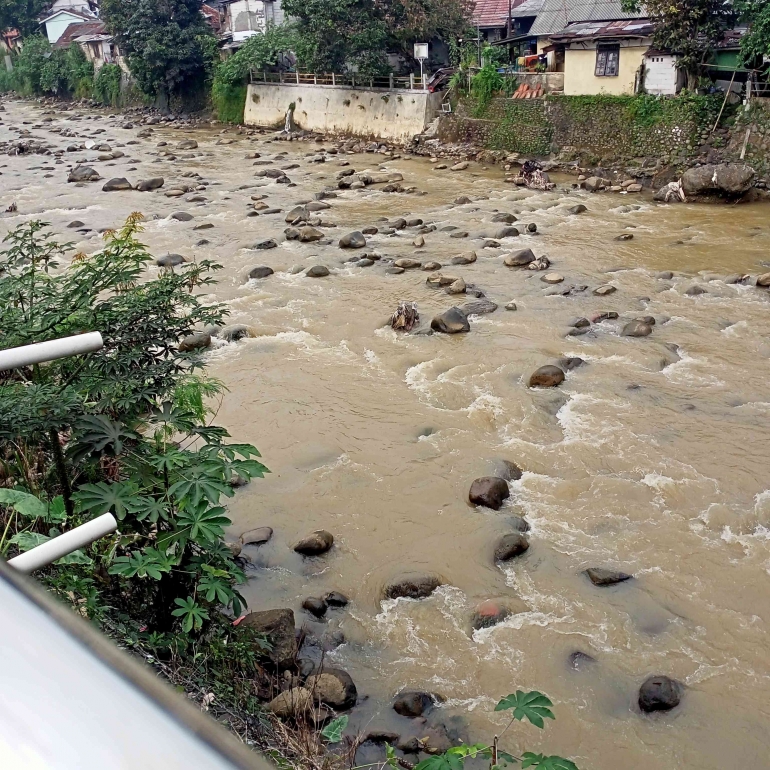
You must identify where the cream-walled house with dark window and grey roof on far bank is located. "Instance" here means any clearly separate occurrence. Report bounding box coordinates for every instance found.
[529,0,653,95]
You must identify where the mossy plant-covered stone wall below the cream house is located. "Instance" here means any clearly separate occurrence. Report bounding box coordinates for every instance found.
[439,95,721,163]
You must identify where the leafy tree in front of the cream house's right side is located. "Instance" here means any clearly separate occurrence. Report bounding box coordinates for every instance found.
[622,0,735,91]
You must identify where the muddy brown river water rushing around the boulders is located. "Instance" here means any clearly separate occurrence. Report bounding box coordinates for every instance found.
[0,102,770,770]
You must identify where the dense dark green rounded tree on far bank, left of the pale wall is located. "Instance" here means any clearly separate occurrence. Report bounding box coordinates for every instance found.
[102,0,212,97]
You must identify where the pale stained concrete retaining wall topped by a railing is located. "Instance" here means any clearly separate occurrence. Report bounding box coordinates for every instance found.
[243,83,442,141]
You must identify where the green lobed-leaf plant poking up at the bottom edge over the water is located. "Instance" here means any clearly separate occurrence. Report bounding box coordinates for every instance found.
[386,690,578,770]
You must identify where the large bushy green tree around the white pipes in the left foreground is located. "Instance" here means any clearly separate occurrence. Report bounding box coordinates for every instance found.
[0,215,267,638]
